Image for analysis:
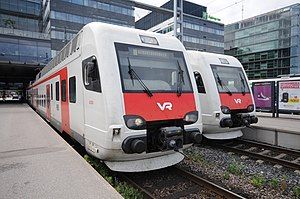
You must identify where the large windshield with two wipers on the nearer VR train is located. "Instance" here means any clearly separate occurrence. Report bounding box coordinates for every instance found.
[115,43,192,93]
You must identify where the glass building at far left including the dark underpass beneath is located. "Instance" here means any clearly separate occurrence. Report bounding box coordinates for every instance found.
[0,0,51,93]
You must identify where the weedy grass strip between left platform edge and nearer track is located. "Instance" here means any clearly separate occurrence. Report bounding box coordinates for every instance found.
[84,155,143,199]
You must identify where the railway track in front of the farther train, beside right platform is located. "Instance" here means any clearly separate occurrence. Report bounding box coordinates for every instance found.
[210,139,300,170]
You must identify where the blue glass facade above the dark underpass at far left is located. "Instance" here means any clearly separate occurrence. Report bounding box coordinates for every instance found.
[0,0,51,66]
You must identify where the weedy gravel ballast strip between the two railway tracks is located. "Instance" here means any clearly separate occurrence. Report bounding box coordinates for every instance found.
[179,145,300,199]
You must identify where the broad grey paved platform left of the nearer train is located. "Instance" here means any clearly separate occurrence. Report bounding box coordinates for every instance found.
[0,104,122,199]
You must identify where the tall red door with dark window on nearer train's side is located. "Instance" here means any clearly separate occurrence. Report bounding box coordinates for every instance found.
[60,68,71,134]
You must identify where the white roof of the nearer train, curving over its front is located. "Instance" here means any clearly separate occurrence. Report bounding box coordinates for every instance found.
[33,22,184,84]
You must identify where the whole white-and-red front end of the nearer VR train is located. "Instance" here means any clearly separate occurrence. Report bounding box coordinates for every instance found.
[86,25,202,172]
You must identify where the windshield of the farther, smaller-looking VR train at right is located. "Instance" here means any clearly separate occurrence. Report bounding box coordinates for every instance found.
[211,65,249,94]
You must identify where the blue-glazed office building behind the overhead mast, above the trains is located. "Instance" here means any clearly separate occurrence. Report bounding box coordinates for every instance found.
[135,0,224,54]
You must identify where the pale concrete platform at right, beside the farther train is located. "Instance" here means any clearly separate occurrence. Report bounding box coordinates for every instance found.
[242,114,300,150]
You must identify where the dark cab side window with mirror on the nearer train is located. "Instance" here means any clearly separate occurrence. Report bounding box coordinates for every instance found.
[82,56,101,93]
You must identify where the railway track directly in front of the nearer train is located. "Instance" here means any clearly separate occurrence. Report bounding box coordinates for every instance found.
[120,167,244,199]
